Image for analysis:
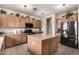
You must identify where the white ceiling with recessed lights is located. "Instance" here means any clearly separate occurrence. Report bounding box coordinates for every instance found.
[0,4,78,17]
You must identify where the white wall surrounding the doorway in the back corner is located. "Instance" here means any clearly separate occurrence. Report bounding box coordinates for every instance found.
[41,14,55,35]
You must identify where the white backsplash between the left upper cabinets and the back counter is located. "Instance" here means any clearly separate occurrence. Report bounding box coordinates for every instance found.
[0,28,40,34]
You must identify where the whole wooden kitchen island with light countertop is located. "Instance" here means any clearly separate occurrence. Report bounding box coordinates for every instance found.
[27,34,59,55]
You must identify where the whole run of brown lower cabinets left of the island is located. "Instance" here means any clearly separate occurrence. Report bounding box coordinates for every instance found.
[5,34,27,48]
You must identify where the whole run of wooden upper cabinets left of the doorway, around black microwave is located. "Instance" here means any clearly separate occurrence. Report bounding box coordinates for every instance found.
[0,14,42,28]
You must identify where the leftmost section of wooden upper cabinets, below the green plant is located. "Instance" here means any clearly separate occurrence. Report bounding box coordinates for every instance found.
[0,15,14,28]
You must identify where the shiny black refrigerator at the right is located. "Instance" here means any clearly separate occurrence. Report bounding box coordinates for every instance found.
[60,20,78,48]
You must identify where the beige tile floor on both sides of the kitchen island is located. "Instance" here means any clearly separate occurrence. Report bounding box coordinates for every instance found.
[2,44,79,55]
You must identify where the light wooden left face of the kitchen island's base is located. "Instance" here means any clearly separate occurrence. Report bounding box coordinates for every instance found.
[27,37,42,55]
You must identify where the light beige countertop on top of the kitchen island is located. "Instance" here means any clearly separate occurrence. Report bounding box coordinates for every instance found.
[28,34,57,40]
